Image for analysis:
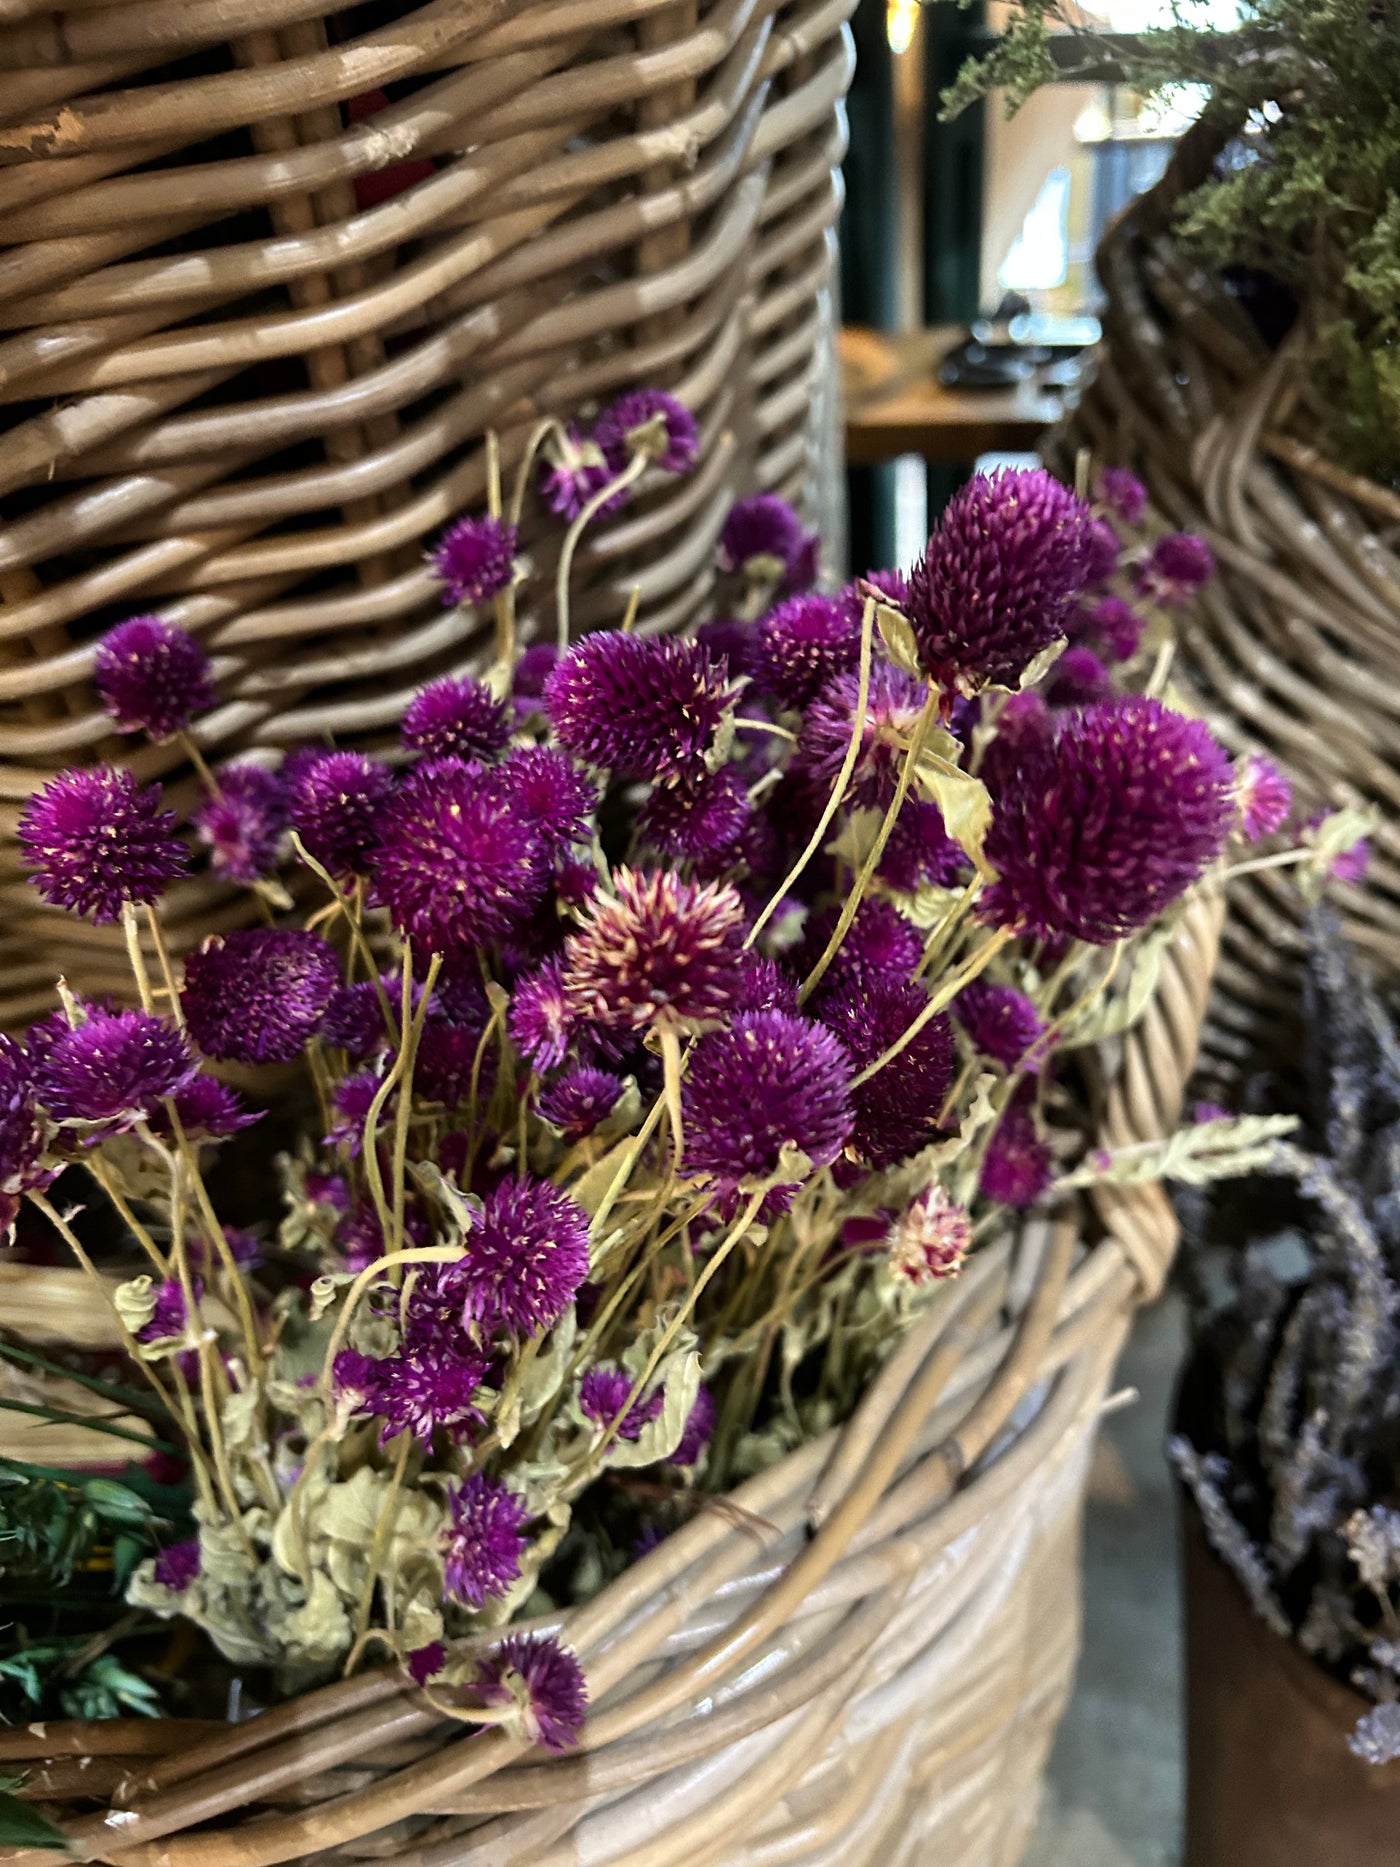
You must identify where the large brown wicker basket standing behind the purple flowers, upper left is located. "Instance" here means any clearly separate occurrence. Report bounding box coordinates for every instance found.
[0,0,855,1025]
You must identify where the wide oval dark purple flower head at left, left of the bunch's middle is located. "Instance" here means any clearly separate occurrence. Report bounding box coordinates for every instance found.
[179,928,340,1062]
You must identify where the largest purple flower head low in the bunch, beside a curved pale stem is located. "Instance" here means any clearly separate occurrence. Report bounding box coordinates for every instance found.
[454,1176,588,1341]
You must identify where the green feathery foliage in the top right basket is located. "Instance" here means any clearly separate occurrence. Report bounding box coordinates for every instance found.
[945,0,1400,482]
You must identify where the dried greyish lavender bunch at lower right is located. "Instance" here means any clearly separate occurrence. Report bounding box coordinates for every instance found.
[1170,909,1400,1762]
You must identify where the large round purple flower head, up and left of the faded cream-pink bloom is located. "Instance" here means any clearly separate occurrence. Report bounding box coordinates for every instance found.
[373,758,549,952]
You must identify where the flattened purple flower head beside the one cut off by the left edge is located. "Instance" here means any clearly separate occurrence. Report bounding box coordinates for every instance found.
[34,1012,194,1133]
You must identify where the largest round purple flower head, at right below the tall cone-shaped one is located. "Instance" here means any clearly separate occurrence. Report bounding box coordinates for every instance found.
[982,695,1236,947]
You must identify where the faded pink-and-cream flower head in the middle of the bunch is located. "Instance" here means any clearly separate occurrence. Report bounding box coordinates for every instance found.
[564,868,743,1031]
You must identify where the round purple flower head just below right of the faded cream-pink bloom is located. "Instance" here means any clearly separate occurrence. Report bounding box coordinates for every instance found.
[681,1012,851,1206]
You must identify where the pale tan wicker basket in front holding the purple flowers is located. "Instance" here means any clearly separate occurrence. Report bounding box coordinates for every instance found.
[0,894,1243,1867]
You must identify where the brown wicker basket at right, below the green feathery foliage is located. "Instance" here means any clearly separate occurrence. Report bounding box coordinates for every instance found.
[1049,125,1400,1087]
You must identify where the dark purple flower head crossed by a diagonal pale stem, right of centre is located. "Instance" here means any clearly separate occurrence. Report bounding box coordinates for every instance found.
[818,976,958,1167]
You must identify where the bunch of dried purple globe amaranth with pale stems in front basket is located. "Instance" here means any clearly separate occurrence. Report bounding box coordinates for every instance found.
[0,429,1337,1746]
